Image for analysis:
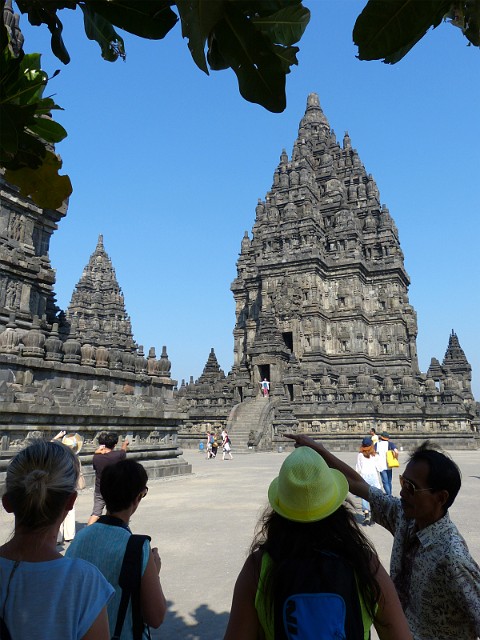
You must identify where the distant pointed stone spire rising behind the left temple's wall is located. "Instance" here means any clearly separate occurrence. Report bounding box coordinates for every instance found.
[66,235,137,351]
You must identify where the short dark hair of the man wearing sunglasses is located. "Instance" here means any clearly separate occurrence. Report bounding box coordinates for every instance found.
[410,440,462,513]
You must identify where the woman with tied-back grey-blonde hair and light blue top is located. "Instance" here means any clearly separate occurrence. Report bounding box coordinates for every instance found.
[0,440,114,640]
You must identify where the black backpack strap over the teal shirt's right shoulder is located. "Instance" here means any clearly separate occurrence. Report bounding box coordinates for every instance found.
[112,535,151,640]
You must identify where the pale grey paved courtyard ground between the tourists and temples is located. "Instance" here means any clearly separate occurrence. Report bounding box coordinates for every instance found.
[0,451,480,640]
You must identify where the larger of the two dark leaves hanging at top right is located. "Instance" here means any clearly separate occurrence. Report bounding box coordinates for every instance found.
[353,0,451,63]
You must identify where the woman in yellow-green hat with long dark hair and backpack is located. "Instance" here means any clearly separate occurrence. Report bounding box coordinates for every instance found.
[224,447,412,640]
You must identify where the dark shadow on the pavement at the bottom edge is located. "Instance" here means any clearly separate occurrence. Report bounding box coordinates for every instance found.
[151,602,229,640]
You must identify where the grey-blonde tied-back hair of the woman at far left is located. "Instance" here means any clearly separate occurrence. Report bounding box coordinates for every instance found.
[5,440,80,530]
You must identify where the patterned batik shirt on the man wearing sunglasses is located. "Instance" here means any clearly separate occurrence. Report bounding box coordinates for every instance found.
[369,487,480,640]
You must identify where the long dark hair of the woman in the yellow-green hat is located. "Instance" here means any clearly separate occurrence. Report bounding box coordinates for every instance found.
[250,501,381,619]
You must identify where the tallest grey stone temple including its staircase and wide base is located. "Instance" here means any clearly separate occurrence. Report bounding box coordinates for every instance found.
[177,94,479,449]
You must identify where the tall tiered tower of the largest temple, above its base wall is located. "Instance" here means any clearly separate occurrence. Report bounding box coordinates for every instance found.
[232,94,418,386]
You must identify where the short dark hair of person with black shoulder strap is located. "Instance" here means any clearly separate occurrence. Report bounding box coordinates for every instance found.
[100,460,148,513]
